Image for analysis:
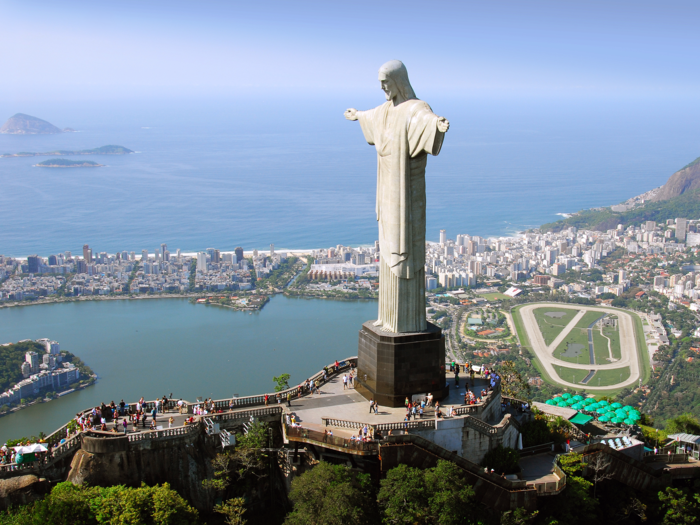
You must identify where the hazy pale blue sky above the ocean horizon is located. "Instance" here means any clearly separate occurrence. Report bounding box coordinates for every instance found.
[0,0,700,102]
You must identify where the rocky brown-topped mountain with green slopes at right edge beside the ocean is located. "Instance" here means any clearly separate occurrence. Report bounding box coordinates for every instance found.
[540,157,700,232]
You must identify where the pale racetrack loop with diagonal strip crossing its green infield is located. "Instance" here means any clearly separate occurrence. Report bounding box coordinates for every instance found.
[517,303,639,390]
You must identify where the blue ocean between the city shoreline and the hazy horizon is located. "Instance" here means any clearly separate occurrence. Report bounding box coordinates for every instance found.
[0,93,700,256]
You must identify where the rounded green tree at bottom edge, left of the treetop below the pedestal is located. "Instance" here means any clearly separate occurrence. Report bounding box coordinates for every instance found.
[284,461,378,525]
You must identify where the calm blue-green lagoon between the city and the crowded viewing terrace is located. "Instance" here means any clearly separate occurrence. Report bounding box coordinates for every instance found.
[0,295,377,444]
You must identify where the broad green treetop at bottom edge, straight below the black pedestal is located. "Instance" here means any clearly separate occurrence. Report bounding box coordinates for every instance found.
[378,460,474,525]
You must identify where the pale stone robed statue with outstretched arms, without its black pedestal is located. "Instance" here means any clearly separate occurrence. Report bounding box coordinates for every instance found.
[345,60,450,333]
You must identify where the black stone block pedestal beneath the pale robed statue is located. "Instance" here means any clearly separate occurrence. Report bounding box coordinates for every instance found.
[356,321,447,407]
